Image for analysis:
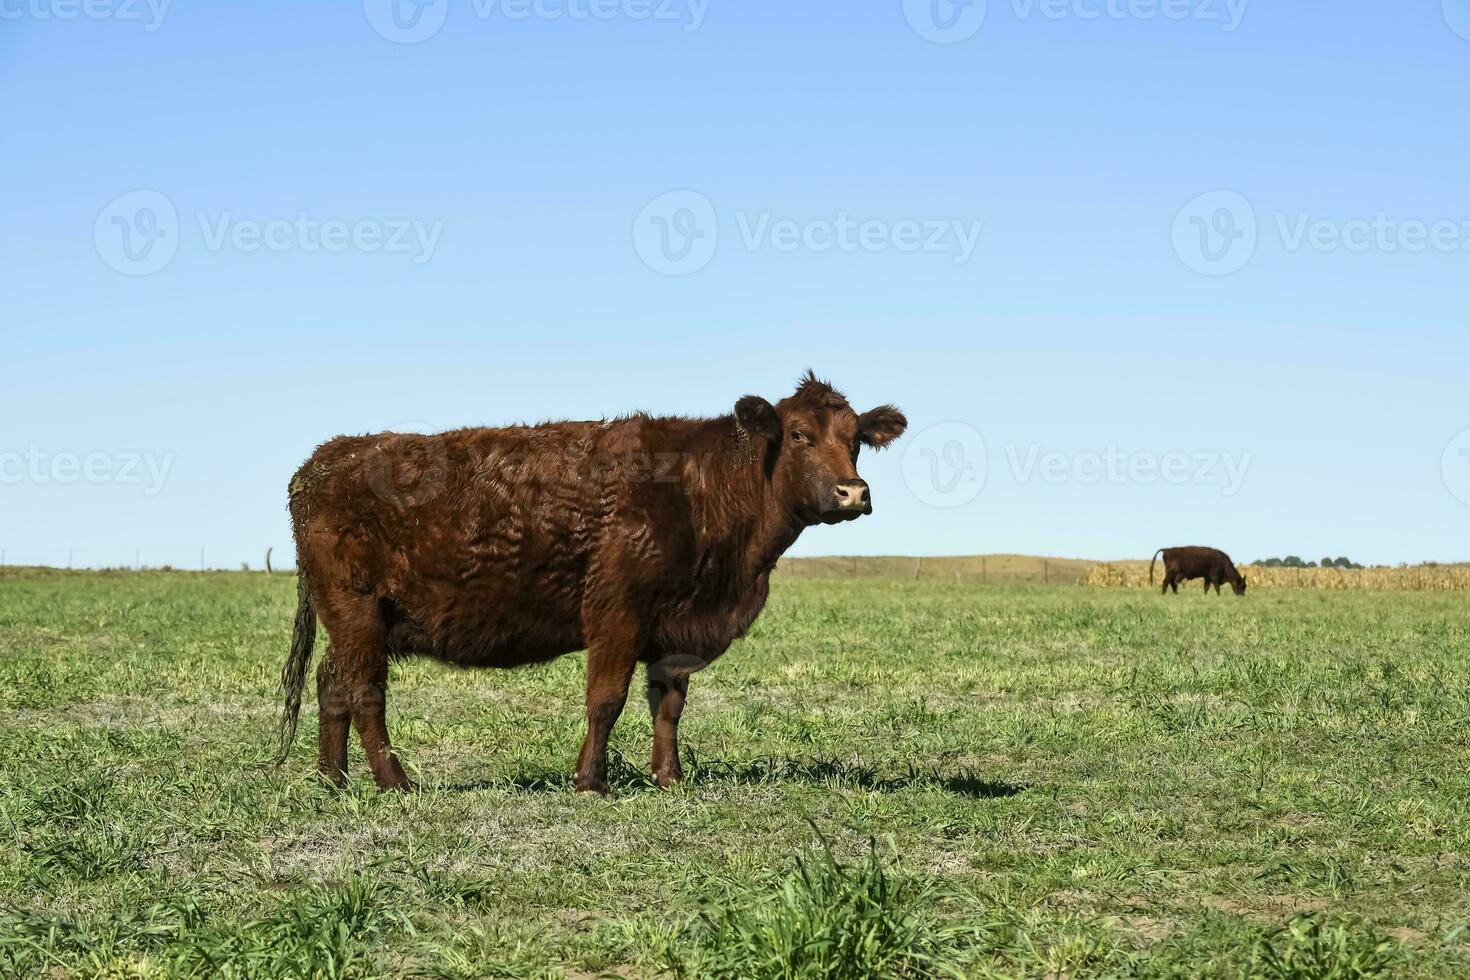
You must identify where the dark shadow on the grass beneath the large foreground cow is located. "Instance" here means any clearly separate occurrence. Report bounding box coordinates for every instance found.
[447,752,1026,799]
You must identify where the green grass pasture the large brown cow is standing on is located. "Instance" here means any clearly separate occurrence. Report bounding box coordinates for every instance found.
[0,570,1470,977]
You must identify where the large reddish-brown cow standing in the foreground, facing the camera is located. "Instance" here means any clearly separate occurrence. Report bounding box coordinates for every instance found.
[270,372,908,792]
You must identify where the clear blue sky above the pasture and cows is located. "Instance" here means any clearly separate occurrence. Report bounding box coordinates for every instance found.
[0,0,1470,566]
